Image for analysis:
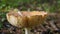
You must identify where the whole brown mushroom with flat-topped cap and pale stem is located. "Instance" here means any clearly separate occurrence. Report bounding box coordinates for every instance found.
[6,10,47,34]
